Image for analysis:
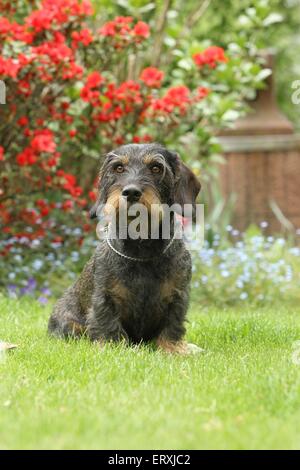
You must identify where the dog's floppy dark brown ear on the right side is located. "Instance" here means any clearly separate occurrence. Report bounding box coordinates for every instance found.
[175,156,201,207]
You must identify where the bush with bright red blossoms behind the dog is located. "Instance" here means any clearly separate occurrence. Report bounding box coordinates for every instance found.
[0,0,268,298]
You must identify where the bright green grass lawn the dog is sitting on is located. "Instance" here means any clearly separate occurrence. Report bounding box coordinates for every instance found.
[0,297,300,449]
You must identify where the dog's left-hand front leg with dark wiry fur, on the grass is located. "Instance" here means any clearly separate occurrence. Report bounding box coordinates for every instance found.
[87,293,128,344]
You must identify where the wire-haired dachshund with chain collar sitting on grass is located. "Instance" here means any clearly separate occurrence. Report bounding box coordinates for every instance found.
[48,143,201,354]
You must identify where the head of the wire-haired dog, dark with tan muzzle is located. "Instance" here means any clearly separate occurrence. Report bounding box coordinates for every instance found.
[90,144,201,222]
